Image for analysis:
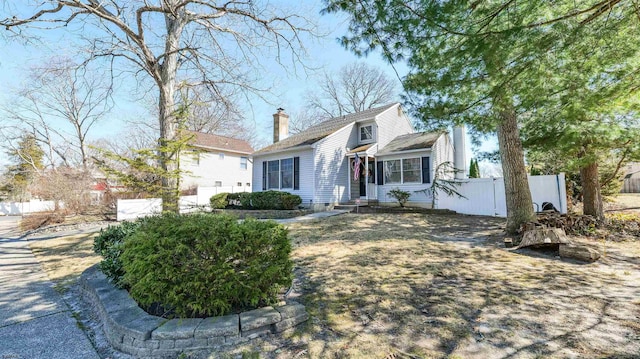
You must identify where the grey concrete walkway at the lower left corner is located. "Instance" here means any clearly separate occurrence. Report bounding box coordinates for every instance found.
[0,217,99,359]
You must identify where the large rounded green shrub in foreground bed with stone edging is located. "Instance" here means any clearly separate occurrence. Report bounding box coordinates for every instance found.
[121,214,293,317]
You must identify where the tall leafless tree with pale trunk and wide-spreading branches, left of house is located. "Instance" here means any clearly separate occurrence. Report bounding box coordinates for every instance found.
[0,0,307,211]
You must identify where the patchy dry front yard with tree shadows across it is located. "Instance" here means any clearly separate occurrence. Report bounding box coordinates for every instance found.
[32,214,640,359]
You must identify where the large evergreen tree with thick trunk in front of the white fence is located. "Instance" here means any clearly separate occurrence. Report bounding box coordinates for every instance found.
[326,0,637,233]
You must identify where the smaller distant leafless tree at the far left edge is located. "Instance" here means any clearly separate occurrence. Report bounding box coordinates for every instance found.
[3,58,111,170]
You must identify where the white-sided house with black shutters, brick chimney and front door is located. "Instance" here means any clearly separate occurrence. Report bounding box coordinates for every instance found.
[252,103,464,209]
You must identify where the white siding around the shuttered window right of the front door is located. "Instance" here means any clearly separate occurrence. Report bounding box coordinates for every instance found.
[376,150,434,207]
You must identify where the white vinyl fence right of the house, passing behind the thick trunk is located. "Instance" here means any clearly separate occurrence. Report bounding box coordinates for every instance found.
[436,173,567,217]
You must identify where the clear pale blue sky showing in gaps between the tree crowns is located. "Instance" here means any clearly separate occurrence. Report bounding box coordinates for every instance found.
[0,0,491,174]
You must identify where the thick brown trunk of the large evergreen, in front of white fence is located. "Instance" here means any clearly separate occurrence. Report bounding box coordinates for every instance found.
[498,106,535,234]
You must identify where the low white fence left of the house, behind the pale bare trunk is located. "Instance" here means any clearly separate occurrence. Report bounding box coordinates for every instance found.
[116,186,246,221]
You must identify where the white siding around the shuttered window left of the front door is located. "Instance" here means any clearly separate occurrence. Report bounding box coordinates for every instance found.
[252,148,316,206]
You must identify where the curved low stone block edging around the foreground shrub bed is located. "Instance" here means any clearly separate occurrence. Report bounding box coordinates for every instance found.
[80,264,309,358]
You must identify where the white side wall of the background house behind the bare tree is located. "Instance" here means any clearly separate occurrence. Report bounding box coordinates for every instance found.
[180,151,252,191]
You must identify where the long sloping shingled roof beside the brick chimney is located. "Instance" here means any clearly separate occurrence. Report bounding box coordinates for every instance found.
[254,102,398,155]
